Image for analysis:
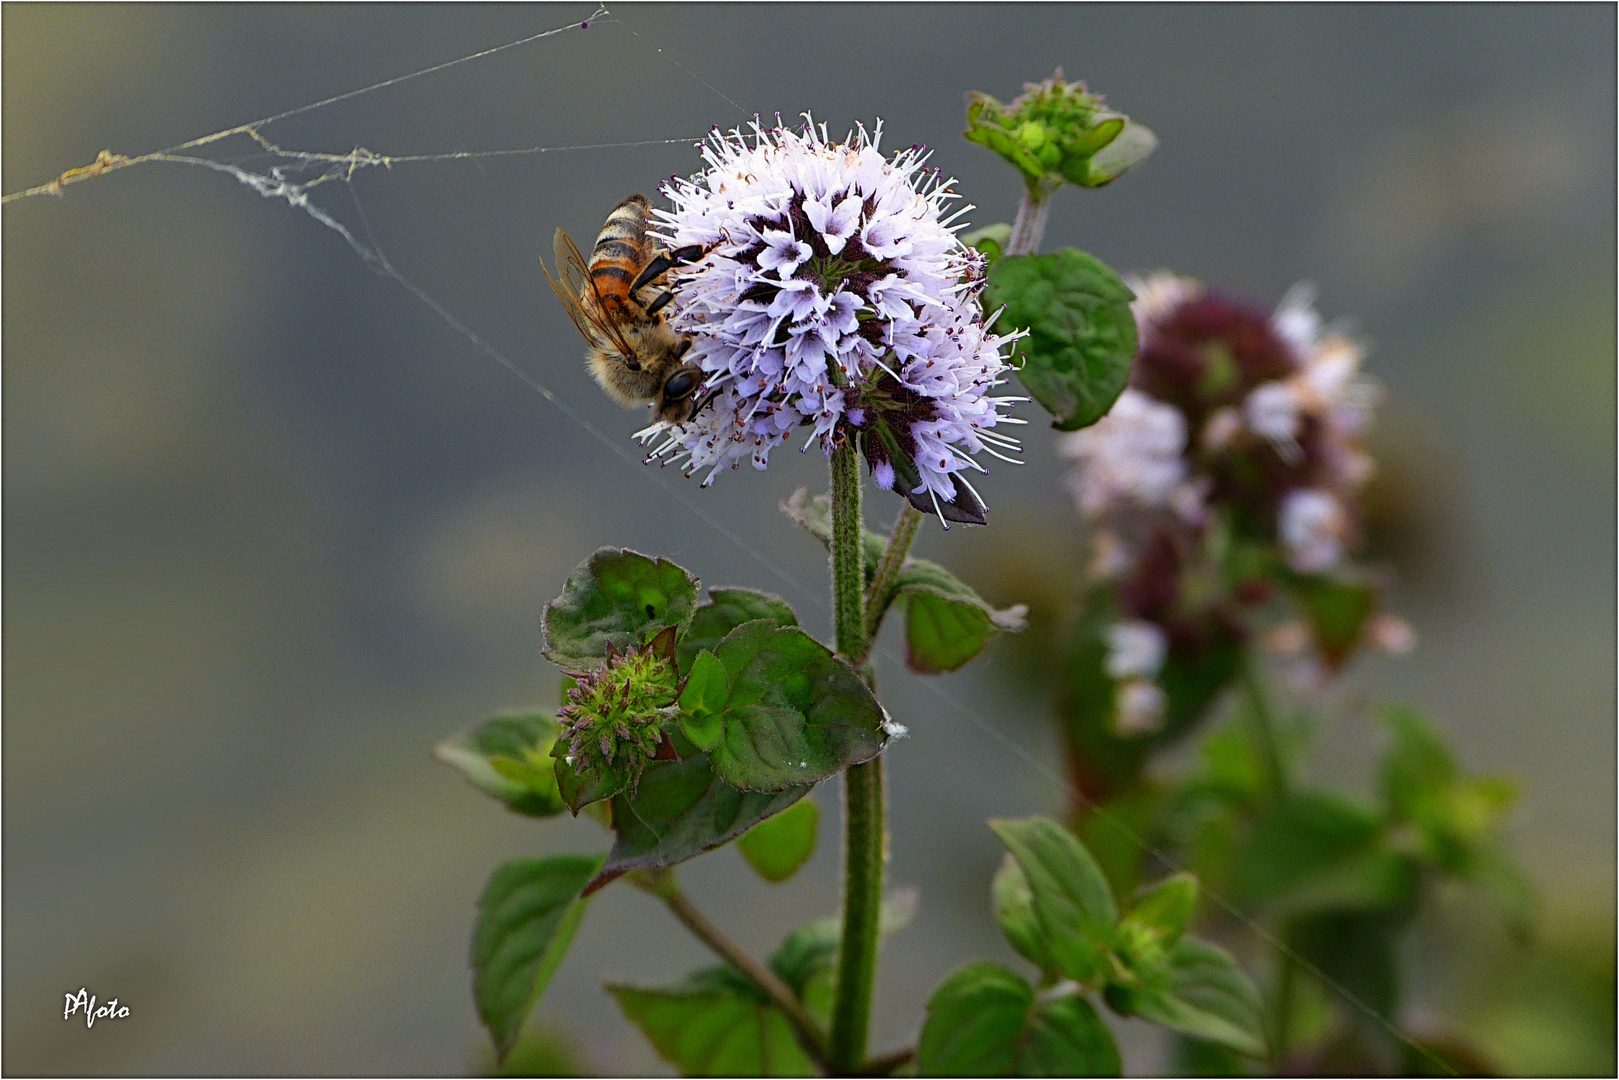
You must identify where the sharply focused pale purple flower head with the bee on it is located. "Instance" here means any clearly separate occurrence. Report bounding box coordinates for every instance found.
[641,121,1023,521]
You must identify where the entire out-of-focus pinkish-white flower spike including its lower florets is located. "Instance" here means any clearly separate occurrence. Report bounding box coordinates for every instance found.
[1059,274,1412,733]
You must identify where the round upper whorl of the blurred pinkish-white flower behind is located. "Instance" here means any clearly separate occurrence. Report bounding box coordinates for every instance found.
[1059,274,1378,573]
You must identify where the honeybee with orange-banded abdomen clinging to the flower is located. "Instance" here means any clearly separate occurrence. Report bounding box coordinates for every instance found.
[539,194,709,424]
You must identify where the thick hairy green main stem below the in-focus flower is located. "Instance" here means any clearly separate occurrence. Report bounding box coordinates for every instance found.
[829,442,884,1075]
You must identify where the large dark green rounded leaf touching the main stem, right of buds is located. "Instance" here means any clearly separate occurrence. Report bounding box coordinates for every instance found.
[712,619,887,792]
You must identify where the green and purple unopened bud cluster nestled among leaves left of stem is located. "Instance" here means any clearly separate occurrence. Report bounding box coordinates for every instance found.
[557,644,678,780]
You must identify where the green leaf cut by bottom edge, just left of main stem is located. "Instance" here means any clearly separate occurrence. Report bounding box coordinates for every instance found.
[607,967,816,1077]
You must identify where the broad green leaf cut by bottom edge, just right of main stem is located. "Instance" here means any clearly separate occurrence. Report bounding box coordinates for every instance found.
[916,963,1120,1077]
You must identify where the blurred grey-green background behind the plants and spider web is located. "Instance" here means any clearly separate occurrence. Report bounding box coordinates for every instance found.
[0,3,1616,1074]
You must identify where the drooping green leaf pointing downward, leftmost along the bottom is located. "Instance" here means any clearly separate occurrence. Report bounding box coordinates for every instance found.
[473,855,602,1054]
